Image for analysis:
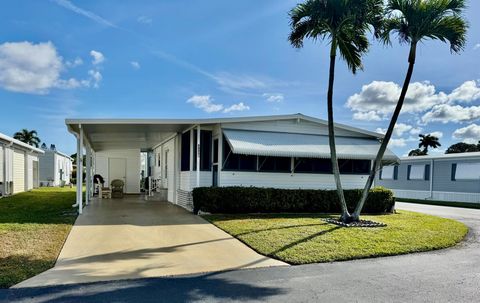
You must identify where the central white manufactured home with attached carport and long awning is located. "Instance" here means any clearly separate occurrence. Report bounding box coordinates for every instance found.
[66,114,398,214]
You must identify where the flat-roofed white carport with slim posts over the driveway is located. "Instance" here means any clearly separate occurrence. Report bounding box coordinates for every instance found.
[65,119,209,214]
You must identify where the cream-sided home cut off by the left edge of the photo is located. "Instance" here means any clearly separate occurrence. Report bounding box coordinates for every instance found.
[0,133,43,196]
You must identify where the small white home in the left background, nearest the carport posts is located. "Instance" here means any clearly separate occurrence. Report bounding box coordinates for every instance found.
[39,145,72,186]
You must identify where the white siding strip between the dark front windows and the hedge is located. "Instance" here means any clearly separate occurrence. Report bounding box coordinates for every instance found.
[220,171,368,189]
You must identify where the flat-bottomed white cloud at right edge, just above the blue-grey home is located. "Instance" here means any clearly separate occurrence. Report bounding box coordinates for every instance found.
[422,104,480,124]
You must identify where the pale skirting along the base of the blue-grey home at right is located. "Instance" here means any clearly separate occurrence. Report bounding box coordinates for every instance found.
[392,189,480,203]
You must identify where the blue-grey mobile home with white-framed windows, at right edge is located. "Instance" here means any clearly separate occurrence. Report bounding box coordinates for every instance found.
[376,152,480,203]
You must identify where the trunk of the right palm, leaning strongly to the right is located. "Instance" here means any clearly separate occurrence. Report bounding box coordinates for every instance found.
[352,42,417,221]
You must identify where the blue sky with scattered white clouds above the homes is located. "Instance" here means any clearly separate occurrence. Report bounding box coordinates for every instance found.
[0,0,480,155]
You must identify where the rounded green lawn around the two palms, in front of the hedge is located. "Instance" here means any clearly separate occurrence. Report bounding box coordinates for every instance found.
[204,211,468,264]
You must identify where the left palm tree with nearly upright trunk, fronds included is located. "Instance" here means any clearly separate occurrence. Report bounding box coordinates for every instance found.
[288,0,383,222]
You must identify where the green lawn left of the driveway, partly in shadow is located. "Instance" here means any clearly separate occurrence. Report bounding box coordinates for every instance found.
[0,188,77,287]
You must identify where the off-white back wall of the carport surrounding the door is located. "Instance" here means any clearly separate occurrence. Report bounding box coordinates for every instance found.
[95,149,140,193]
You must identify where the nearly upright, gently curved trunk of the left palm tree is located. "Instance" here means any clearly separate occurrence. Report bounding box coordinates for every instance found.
[327,39,351,223]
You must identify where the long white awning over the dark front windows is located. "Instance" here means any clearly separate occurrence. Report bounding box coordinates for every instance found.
[223,129,399,162]
